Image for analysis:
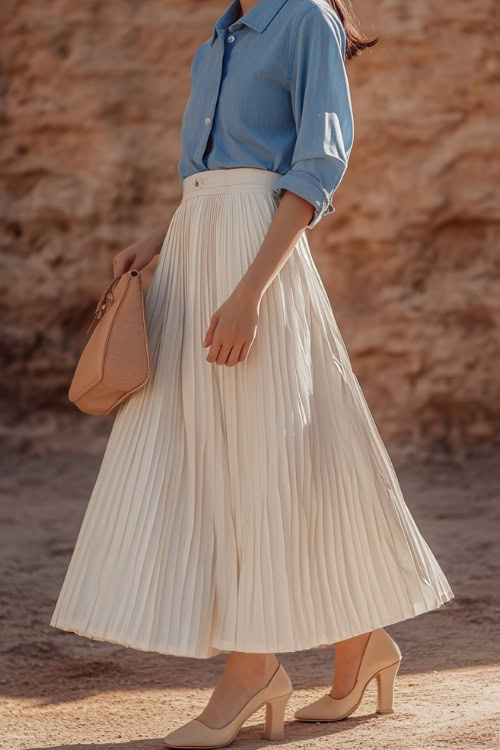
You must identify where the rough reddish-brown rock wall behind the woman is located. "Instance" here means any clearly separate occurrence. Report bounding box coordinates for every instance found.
[0,0,500,453]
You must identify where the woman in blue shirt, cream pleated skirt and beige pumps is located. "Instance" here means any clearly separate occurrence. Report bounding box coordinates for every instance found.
[51,0,453,747]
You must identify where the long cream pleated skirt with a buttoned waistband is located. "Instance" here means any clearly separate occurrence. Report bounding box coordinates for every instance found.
[50,168,454,658]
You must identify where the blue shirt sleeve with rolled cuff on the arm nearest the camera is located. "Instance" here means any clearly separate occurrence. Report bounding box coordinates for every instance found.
[273,5,354,229]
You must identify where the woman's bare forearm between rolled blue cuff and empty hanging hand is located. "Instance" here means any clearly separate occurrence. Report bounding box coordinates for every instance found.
[235,190,314,301]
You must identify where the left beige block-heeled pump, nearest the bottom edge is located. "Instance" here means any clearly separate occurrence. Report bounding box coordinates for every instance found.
[164,664,293,748]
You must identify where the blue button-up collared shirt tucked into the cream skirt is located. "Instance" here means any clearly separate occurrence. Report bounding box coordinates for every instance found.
[178,0,354,228]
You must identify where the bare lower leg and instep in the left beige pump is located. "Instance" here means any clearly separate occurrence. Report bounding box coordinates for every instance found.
[198,651,279,729]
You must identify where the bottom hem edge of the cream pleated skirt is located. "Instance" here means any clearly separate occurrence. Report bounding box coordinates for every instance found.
[50,589,455,659]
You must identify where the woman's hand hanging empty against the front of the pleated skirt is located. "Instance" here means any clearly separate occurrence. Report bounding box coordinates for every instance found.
[202,287,261,367]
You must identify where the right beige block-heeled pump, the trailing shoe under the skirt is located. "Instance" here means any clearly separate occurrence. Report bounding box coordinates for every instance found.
[294,628,401,721]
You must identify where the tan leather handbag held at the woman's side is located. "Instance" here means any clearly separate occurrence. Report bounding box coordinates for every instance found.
[68,270,151,414]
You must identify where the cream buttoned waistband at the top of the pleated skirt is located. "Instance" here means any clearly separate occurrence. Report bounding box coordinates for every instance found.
[182,167,282,200]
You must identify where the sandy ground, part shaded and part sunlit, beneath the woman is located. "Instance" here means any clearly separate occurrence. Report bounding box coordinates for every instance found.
[0,454,500,750]
